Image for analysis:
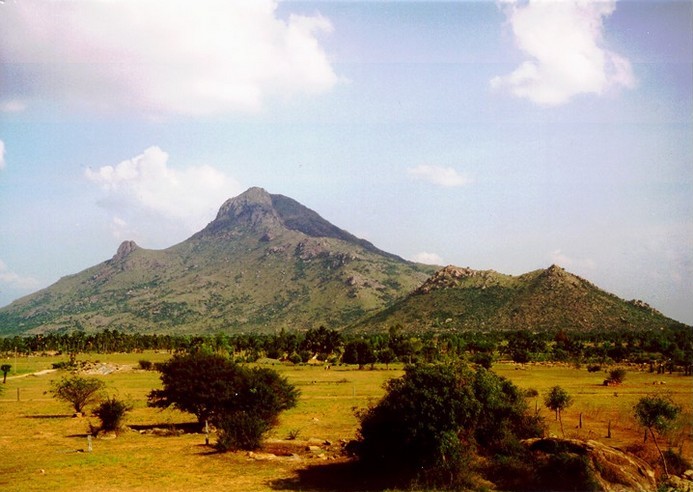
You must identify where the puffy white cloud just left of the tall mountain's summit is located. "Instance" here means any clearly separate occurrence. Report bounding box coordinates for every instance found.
[85,146,242,239]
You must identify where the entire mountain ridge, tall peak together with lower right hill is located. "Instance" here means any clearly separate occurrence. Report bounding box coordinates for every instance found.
[0,188,686,336]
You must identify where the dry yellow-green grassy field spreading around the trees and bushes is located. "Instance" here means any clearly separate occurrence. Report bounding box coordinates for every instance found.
[0,353,693,491]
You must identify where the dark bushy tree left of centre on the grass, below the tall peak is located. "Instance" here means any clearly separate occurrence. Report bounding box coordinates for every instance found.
[148,352,298,451]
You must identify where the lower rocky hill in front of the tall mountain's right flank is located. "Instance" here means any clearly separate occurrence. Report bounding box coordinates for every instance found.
[350,265,686,331]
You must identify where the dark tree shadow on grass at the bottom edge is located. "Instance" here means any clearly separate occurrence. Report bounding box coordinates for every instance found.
[269,461,397,492]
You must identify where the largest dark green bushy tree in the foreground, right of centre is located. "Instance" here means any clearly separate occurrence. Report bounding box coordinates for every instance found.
[351,364,541,487]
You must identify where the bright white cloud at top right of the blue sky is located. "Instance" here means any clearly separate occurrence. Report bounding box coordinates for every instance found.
[491,0,635,106]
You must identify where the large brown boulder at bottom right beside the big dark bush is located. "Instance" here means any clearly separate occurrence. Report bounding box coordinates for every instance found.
[523,438,657,492]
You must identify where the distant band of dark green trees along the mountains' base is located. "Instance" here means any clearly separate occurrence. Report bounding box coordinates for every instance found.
[0,326,693,374]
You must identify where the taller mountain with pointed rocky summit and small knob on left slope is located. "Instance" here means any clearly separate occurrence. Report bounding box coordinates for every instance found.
[0,188,434,335]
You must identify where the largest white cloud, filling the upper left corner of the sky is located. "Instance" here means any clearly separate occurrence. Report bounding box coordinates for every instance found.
[0,0,337,117]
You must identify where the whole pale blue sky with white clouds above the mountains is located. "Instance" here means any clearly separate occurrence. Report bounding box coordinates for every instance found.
[0,0,693,324]
